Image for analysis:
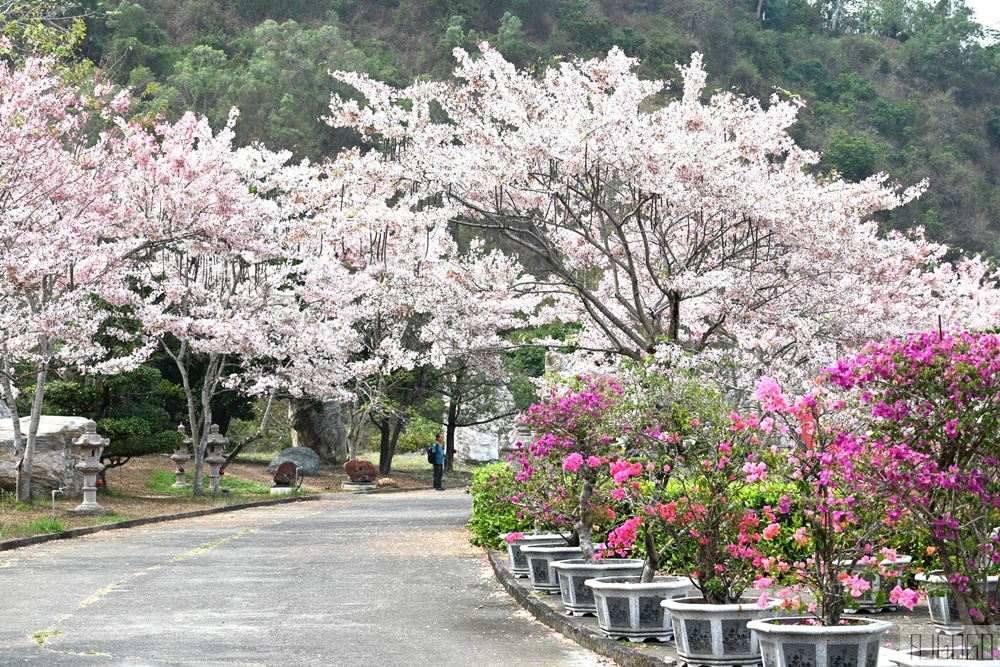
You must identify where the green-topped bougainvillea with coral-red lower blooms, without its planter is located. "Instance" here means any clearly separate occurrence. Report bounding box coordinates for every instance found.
[608,376,772,603]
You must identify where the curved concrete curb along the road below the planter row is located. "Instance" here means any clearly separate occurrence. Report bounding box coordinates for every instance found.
[486,549,675,667]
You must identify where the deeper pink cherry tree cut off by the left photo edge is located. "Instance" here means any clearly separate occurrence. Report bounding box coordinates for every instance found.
[0,48,129,501]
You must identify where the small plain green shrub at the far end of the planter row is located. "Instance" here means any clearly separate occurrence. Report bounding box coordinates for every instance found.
[466,462,532,548]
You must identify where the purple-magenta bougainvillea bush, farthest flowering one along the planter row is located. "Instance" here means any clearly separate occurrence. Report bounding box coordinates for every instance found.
[511,377,622,560]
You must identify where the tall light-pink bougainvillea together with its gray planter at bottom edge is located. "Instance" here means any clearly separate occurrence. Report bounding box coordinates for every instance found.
[748,377,916,667]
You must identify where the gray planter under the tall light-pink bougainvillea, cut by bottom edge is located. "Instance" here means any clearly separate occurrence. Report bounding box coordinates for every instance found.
[747,616,892,667]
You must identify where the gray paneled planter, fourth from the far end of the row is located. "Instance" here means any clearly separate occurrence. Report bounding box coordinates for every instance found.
[587,576,694,642]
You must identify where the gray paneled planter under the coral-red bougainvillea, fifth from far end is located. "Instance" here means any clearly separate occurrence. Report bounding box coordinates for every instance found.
[660,598,774,667]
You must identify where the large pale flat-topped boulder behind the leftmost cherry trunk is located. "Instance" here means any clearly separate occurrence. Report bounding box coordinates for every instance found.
[0,416,83,498]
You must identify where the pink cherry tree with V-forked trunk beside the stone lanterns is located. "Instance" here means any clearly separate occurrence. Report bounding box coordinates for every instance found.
[103,108,296,493]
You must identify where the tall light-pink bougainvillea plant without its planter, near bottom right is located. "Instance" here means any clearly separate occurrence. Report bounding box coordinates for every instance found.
[748,377,916,625]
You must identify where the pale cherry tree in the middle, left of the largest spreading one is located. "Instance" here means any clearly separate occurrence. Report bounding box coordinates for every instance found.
[266,151,540,473]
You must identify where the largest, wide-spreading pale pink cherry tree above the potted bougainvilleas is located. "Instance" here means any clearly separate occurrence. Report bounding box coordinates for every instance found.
[329,44,998,386]
